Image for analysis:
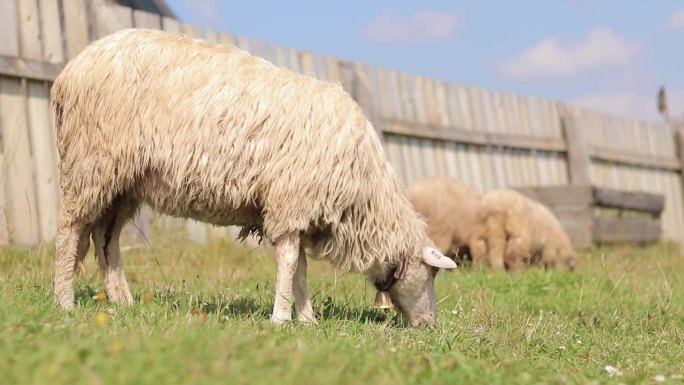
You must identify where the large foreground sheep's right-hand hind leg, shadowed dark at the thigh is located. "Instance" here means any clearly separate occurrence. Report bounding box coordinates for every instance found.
[93,200,135,305]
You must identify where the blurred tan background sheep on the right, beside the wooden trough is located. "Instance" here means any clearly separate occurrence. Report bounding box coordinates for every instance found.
[473,190,577,270]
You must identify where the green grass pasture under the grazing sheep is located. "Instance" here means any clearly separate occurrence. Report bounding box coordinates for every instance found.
[0,230,684,385]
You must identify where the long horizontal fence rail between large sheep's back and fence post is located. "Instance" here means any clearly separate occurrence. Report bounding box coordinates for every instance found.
[379,120,566,152]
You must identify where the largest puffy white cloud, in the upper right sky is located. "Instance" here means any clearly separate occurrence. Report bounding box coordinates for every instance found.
[498,28,641,80]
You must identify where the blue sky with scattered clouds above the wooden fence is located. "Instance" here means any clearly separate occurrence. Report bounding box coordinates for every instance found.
[167,0,684,121]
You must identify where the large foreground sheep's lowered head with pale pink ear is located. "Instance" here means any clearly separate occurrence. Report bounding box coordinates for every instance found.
[375,246,456,326]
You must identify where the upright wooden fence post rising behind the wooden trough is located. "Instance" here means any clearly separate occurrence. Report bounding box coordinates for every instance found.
[561,113,591,185]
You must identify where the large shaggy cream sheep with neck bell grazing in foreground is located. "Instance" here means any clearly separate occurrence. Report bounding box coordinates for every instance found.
[52,29,456,325]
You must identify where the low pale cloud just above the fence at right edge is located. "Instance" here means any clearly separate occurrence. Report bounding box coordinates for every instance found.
[570,89,684,121]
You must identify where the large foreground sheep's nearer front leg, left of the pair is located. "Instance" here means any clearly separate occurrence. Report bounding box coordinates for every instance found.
[271,233,299,325]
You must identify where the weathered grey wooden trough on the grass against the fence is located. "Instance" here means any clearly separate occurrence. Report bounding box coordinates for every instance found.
[515,185,665,247]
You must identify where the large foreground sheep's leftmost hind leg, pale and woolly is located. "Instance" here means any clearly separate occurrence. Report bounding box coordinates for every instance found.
[54,214,86,310]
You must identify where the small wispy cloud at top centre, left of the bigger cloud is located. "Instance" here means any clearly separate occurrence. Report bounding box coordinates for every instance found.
[365,11,457,43]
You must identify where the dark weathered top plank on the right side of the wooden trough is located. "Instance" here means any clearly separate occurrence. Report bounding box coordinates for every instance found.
[594,187,665,215]
